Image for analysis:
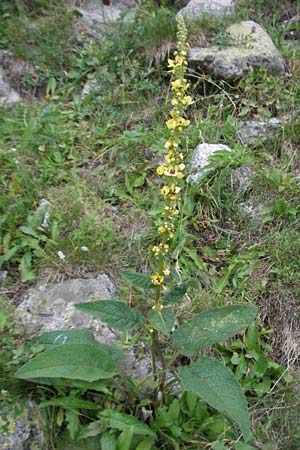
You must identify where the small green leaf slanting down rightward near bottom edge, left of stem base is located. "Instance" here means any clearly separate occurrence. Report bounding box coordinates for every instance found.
[102,409,156,437]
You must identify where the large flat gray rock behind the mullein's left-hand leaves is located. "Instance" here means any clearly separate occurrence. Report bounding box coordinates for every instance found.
[15,274,151,379]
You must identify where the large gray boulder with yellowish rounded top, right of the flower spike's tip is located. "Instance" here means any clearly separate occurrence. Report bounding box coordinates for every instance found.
[188,20,286,81]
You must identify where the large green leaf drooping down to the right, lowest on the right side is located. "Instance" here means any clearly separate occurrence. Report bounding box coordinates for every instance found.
[179,356,250,440]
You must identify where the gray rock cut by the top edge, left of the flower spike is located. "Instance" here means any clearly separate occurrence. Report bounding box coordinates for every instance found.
[76,0,136,38]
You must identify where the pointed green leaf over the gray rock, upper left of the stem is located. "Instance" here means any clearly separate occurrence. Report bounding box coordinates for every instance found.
[75,300,146,331]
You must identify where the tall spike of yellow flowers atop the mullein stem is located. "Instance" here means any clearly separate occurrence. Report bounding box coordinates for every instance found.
[151,16,193,288]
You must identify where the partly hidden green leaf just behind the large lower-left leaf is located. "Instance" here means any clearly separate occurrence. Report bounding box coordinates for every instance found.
[31,329,96,346]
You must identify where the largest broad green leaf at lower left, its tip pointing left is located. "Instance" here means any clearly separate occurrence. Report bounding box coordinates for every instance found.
[15,343,117,381]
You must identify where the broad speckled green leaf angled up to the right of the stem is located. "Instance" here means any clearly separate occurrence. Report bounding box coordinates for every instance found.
[173,305,256,356]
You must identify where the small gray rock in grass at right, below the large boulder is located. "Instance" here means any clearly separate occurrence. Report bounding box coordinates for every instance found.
[237,117,283,145]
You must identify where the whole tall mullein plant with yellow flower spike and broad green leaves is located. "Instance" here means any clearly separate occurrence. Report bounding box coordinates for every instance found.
[16,16,256,449]
